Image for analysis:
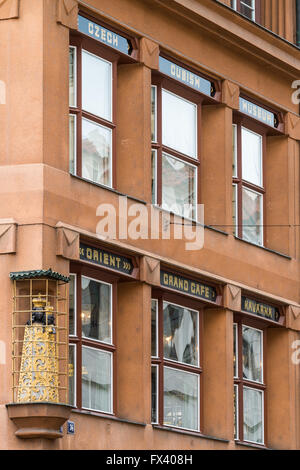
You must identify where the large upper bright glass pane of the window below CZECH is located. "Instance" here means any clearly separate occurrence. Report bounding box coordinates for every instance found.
[82,51,112,121]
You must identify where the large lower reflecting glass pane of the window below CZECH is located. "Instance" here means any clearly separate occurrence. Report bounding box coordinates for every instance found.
[82,119,112,186]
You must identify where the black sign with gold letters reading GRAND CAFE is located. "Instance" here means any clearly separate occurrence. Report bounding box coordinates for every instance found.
[160,271,217,302]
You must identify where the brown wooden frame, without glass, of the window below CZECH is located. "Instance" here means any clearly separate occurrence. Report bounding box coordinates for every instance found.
[69,34,120,189]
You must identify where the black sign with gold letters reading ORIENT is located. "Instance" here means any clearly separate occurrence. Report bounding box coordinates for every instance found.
[80,243,134,275]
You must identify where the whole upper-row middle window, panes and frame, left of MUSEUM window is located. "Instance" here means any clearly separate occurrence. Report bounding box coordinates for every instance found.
[151,78,201,220]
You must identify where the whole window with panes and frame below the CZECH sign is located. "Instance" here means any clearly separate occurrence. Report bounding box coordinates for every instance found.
[69,38,117,187]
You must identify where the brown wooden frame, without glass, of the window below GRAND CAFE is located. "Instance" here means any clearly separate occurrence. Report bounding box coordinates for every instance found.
[151,289,203,434]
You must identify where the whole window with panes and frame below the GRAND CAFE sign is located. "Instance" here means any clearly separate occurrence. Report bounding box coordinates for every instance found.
[151,296,201,431]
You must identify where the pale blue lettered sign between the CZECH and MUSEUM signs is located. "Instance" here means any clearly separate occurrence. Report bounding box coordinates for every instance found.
[159,57,212,96]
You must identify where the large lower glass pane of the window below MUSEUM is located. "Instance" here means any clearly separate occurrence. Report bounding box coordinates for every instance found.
[242,188,263,245]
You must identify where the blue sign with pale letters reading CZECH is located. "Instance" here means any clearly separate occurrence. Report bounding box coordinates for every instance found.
[78,15,132,55]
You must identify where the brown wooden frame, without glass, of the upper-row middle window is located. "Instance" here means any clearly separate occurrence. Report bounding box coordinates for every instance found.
[151,73,204,221]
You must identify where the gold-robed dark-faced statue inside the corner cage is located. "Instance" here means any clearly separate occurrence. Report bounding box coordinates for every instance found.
[17,294,59,403]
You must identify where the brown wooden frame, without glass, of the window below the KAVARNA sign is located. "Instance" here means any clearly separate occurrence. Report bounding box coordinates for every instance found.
[233,314,268,448]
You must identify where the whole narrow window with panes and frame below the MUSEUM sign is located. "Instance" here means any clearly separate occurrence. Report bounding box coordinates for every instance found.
[232,124,265,246]
